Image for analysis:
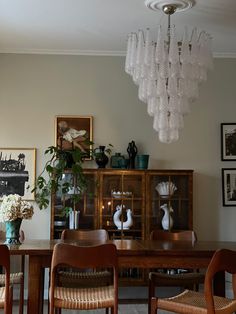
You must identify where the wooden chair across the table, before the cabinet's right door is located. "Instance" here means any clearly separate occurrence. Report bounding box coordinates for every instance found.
[148,230,205,313]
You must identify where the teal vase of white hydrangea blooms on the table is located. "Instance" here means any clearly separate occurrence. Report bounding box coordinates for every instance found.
[0,194,34,244]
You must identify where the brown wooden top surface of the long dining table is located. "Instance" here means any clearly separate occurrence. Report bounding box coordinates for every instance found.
[0,239,236,256]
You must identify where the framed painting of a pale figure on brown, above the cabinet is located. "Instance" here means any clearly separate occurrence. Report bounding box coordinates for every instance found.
[55,116,93,159]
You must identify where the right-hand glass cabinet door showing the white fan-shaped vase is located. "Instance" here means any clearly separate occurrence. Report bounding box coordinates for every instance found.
[146,171,193,238]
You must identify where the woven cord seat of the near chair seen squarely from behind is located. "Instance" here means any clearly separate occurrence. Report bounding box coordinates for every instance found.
[54,286,115,310]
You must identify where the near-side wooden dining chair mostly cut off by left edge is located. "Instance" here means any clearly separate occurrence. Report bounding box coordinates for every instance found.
[0,244,12,314]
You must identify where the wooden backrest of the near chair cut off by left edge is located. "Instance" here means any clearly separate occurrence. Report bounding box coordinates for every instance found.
[0,244,10,313]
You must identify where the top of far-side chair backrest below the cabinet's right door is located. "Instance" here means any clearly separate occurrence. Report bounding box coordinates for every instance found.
[150,230,197,242]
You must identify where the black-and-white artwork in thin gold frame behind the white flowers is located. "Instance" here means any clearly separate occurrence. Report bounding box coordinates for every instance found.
[0,148,36,201]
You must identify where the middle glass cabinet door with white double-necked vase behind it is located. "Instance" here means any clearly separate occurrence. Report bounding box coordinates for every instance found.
[100,171,145,239]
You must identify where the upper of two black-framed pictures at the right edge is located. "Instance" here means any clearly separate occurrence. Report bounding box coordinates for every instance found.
[221,123,236,160]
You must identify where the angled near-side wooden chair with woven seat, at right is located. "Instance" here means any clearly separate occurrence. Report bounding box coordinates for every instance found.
[151,249,236,314]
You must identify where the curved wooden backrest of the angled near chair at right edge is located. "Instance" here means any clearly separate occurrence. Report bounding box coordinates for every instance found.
[204,249,236,313]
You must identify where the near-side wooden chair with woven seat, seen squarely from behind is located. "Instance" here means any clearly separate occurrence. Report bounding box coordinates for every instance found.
[49,243,118,314]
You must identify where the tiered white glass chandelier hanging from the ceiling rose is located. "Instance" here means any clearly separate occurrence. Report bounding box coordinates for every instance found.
[125,0,213,143]
